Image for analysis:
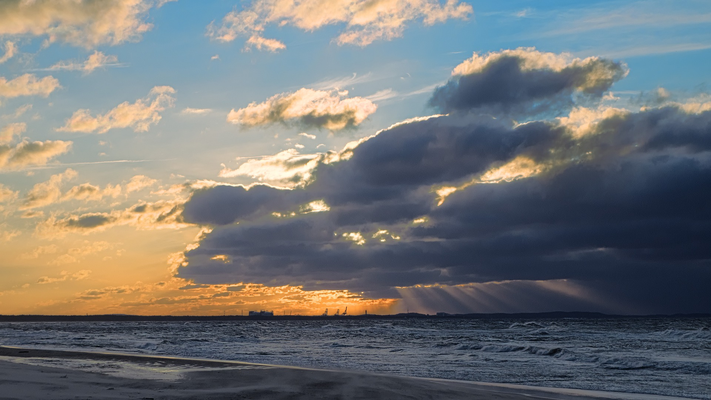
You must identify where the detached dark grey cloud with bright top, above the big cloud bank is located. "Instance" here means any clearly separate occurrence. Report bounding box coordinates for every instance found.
[430,48,628,116]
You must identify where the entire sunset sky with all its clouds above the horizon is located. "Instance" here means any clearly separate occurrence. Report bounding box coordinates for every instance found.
[0,0,711,315]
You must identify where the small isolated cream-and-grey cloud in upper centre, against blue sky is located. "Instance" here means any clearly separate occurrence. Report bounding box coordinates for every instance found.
[227,88,377,130]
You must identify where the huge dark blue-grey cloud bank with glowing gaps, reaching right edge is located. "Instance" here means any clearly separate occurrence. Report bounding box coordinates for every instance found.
[178,83,711,313]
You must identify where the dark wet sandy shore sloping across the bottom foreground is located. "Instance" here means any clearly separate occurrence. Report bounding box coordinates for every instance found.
[0,346,692,400]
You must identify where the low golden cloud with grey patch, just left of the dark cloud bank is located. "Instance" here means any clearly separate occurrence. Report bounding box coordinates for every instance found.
[35,201,191,239]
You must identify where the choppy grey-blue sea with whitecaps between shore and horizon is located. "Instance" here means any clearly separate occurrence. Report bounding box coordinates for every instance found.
[0,317,711,399]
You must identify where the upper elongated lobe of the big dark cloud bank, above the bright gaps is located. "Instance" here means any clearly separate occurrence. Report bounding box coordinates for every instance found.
[183,118,570,225]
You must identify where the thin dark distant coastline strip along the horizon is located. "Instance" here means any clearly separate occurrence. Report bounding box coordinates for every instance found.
[0,311,711,322]
